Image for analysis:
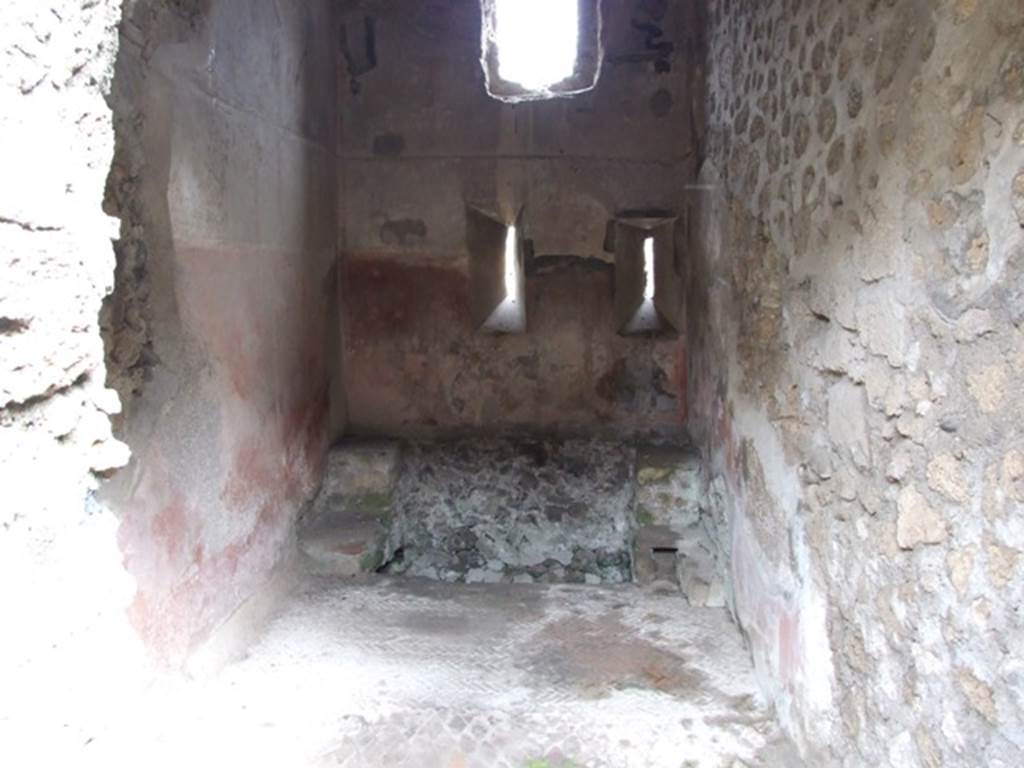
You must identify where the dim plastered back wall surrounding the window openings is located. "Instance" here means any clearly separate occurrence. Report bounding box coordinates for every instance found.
[339,0,699,433]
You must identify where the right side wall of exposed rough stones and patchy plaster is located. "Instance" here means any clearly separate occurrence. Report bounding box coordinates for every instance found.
[689,0,1024,767]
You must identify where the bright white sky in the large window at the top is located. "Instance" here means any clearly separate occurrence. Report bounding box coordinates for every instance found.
[495,0,580,90]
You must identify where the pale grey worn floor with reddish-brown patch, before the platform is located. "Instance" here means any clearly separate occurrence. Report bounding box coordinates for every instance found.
[119,578,800,768]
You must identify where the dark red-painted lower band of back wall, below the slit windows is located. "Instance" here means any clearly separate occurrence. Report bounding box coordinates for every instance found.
[341,254,686,434]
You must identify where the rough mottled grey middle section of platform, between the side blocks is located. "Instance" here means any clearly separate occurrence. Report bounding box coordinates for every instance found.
[389,439,635,583]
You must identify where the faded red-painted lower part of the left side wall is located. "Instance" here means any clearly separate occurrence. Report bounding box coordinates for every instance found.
[120,247,328,663]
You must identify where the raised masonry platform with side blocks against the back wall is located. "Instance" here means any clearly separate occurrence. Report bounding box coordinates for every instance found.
[299,438,725,606]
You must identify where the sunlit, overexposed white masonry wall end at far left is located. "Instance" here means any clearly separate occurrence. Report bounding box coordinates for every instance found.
[0,0,147,754]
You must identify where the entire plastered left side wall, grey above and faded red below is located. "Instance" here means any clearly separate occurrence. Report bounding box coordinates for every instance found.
[104,0,336,662]
